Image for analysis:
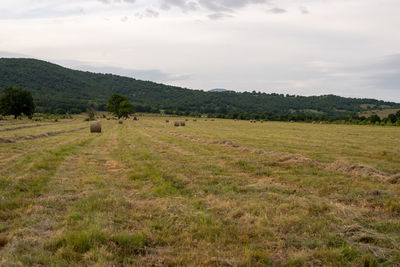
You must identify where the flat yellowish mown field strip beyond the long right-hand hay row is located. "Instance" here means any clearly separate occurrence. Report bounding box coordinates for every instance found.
[143,118,400,173]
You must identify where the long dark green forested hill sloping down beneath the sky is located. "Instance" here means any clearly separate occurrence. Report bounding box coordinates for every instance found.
[0,58,400,116]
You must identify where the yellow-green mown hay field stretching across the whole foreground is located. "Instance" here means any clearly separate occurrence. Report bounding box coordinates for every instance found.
[0,117,400,266]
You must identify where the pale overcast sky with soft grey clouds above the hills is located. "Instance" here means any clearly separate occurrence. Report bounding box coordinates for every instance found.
[0,0,400,102]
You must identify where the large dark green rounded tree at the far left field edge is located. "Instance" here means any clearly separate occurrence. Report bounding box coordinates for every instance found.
[0,86,35,118]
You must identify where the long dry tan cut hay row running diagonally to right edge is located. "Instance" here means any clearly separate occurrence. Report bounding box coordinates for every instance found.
[148,128,400,183]
